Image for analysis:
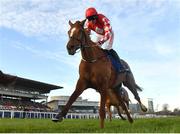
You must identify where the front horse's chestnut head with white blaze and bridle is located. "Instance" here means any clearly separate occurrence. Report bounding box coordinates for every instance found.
[67,20,86,55]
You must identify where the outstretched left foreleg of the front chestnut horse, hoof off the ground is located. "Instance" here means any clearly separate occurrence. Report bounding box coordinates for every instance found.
[53,79,87,122]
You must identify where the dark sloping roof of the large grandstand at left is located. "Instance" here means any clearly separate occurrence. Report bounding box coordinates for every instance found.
[0,70,63,94]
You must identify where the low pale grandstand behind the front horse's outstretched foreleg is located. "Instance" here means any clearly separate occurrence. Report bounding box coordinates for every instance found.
[47,96,99,119]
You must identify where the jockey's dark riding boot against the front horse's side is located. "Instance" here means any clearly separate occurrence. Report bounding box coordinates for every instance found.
[109,49,129,73]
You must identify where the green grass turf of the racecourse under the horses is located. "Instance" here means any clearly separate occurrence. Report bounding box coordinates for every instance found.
[0,117,180,133]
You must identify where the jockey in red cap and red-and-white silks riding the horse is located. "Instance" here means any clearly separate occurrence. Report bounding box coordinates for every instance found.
[86,7,127,72]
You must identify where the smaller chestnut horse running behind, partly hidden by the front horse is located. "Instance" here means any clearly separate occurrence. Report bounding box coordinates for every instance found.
[106,87,130,121]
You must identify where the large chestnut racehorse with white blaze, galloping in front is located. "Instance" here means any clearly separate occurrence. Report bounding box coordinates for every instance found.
[52,20,146,128]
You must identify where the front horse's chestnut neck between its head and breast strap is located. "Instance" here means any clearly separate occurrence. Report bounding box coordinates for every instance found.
[81,40,104,61]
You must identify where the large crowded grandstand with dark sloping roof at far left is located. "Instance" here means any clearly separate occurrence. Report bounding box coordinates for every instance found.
[0,71,62,118]
